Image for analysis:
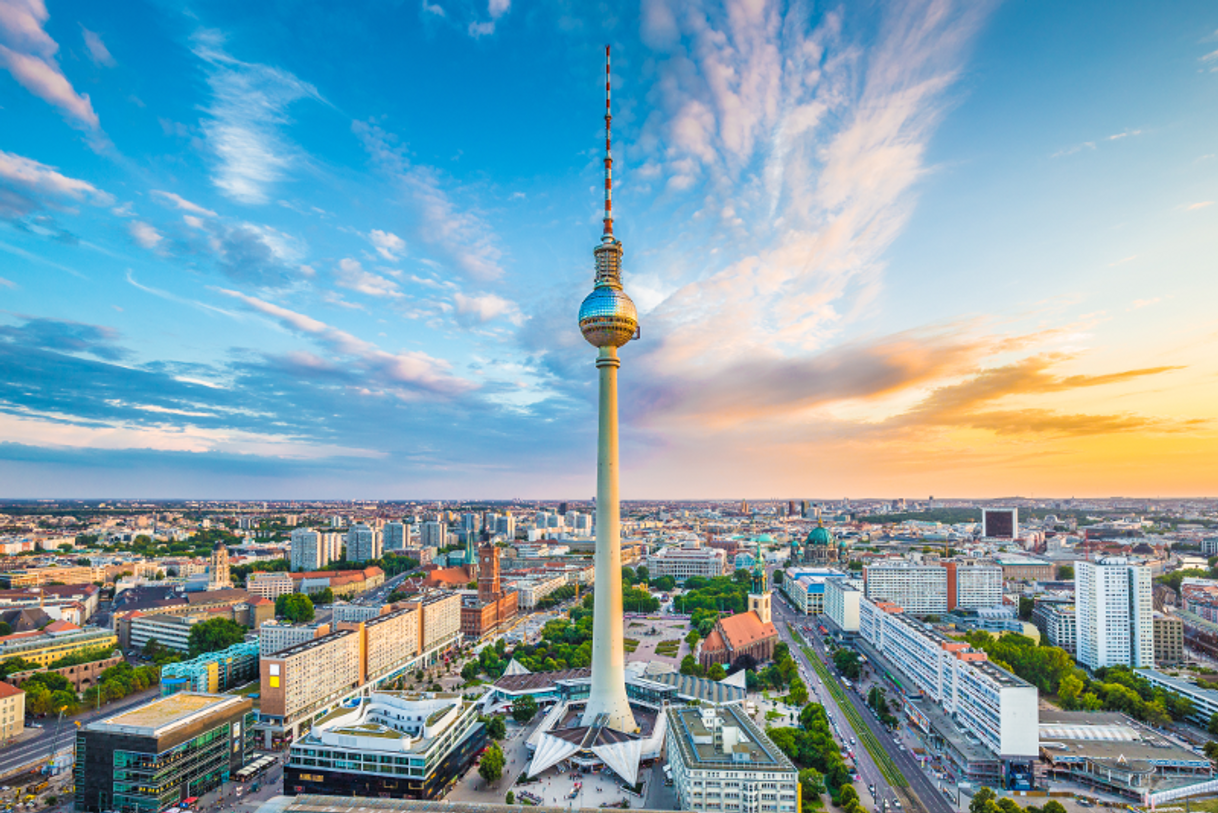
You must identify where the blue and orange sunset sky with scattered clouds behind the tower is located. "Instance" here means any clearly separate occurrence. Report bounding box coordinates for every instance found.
[0,0,1218,500]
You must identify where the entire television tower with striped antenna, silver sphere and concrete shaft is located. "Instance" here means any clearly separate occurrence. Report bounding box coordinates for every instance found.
[580,45,638,731]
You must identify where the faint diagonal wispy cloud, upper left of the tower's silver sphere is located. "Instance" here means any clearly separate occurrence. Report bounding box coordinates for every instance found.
[351,122,503,282]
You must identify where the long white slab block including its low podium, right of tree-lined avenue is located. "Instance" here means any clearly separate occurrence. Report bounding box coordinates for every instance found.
[859,598,1039,787]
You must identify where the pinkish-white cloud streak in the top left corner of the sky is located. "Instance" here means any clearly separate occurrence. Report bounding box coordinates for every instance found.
[0,0,100,130]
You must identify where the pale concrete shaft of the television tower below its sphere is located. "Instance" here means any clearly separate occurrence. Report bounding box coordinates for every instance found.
[581,346,638,731]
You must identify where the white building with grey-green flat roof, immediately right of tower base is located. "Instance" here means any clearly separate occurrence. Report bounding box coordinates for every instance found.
[666,706,801,813]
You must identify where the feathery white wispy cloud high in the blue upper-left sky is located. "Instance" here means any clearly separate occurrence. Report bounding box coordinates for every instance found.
[194,30,322,204]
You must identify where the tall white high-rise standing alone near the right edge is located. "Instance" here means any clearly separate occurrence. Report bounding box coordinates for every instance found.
[1074,557,1155,669]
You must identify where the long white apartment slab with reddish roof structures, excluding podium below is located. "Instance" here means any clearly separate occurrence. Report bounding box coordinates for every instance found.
[859,598,1040,762]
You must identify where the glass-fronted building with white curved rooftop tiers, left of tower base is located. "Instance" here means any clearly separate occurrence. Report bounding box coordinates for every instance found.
[284,692,486,800]
